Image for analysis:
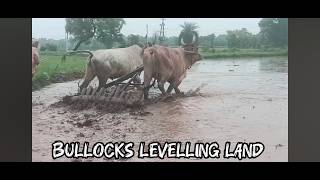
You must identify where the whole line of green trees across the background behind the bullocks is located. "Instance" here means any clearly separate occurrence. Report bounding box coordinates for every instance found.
[39,18,288,51]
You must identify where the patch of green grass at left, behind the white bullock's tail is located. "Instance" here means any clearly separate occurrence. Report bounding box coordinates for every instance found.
[32,54,87,91]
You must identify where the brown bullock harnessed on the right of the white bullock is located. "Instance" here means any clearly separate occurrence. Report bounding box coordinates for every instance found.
[142,45,202,99]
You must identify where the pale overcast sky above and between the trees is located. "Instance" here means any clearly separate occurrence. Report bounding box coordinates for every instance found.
[32,18,262,39]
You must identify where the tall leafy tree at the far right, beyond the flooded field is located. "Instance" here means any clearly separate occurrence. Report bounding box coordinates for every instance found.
[259,18,288,47]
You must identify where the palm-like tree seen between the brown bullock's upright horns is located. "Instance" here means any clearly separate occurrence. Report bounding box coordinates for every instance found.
[179,22,199,45]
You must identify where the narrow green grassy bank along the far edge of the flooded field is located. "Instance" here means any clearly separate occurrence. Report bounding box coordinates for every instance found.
[200,48,288,59]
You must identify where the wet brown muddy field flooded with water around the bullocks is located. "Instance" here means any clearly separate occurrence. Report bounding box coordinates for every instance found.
[32,58,288,161]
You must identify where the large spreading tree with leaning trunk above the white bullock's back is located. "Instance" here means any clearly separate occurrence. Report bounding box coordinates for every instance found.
[65,18,125,51]
